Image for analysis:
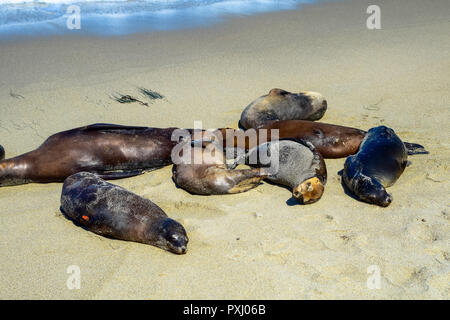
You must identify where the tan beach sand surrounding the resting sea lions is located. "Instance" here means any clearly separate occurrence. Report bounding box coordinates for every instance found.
[0,0,450,299]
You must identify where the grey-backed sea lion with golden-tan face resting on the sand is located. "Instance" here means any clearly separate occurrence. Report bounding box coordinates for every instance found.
[246,139,327,204]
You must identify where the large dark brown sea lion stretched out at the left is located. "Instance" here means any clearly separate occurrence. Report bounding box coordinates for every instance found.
[0,124,185,186]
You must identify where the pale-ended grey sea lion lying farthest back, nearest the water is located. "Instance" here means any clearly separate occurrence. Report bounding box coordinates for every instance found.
[239,89,327,129]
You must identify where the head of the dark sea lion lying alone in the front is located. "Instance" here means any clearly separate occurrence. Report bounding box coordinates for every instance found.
[155,218,189,254]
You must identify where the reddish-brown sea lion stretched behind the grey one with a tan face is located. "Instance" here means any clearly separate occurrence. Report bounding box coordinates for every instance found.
[200,120,428,159]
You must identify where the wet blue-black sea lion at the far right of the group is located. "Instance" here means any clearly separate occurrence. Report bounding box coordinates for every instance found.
[342,126,408,207]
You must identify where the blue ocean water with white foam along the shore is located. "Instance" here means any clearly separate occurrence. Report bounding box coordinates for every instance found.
[0,0,315,39]
